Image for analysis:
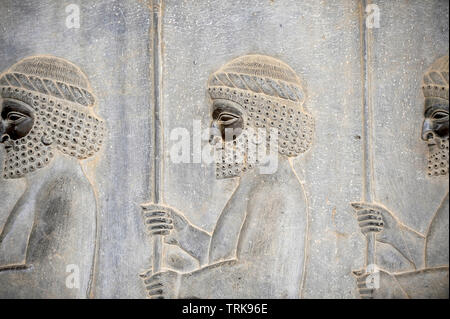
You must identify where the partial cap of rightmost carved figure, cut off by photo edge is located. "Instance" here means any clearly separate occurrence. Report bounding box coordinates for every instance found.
[422,55,449,100]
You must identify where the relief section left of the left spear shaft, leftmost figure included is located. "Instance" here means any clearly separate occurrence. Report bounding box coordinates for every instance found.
[0,0,153,298]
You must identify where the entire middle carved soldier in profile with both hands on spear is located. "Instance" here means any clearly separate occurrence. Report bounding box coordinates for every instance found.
[143,55,314,298]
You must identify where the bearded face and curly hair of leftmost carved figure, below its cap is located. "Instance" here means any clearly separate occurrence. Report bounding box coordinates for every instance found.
[0,88,104,178]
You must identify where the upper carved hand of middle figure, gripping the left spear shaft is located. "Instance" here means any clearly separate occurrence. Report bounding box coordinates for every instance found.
[142,203,189,245]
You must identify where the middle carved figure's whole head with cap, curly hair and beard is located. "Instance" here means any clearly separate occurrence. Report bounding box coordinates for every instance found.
[208,55,314,178]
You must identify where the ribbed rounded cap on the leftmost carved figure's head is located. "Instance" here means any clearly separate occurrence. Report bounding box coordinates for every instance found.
[0,56,95,106]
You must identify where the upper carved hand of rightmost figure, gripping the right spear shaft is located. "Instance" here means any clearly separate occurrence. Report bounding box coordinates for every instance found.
[352,203,400,243]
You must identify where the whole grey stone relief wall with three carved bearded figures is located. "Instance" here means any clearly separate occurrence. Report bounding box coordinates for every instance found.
[0,0,449,298]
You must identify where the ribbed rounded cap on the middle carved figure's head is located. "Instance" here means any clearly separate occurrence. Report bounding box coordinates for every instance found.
[208,55,305,103]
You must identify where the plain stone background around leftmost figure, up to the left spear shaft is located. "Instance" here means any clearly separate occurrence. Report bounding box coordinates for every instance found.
[0,1,152,298]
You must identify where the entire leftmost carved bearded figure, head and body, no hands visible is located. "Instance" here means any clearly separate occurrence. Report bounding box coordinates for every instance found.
[0,56,104,298]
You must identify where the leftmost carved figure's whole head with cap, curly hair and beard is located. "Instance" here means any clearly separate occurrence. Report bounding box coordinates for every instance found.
[0,56,104,178]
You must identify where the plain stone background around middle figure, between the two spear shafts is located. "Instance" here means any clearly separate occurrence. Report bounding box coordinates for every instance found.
[162,1,365,298]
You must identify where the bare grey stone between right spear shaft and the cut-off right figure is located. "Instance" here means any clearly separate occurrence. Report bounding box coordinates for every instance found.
[368,1,449,238]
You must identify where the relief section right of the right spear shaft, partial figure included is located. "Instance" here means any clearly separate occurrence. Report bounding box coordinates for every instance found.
[354,1,448,298]
